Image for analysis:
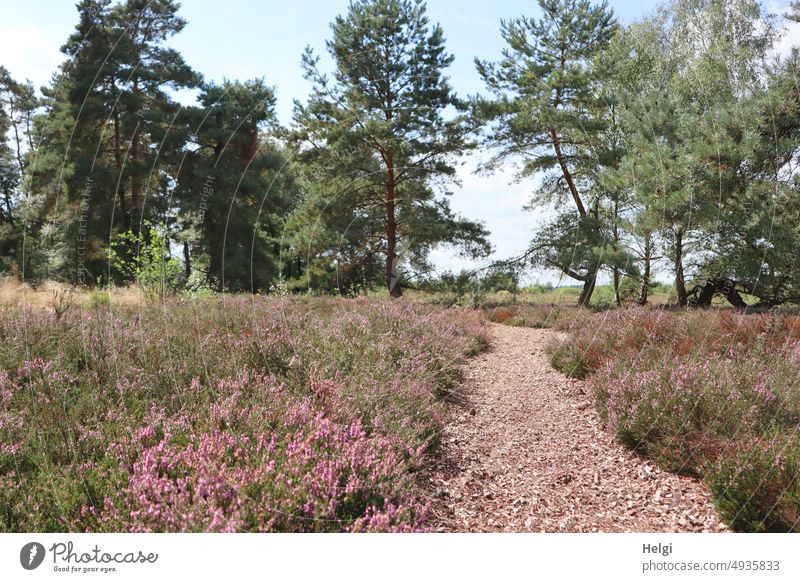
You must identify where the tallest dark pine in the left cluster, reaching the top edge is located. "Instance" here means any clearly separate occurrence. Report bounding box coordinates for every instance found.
[31,0,199,281]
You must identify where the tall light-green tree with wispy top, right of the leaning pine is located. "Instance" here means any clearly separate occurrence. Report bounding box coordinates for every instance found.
[620,0,774,306]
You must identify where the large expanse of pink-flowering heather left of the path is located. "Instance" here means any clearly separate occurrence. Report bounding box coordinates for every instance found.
[0,296,487,531]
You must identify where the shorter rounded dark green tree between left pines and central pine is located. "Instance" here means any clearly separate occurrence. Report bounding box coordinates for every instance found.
[176,80,296,292]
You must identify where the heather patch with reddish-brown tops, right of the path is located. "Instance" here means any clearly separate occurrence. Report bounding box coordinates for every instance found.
[549,309,800,531]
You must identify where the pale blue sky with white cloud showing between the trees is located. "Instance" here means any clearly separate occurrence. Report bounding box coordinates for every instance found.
[0,0,800,282]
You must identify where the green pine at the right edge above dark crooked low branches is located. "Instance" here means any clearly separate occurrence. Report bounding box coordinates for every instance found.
[694,42,800,307]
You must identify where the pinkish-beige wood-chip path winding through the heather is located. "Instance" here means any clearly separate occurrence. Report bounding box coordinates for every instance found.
[429,325,726,532]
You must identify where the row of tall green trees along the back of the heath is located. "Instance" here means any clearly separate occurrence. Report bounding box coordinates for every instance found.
[0,0,800,307]
